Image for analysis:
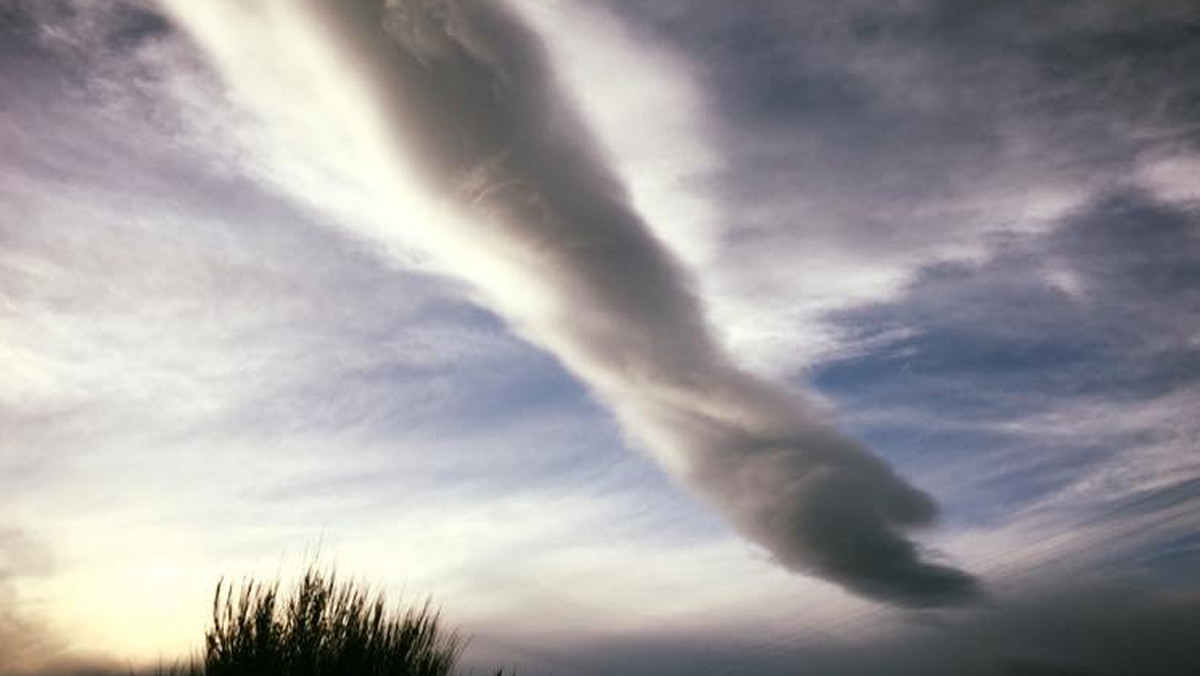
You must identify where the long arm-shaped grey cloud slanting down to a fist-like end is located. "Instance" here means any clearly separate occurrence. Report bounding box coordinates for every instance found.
[166,0,976,605]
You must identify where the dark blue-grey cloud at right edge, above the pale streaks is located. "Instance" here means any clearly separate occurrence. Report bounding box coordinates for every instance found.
[836,187,1200,396]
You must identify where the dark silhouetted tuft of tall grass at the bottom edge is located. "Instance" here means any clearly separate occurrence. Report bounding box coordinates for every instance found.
[196,566,464,676]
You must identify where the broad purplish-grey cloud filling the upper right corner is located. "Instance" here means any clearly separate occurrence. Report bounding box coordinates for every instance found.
[595,0,1200,297]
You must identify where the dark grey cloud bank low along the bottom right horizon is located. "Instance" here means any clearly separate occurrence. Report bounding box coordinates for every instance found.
[480,579,1200,676]
